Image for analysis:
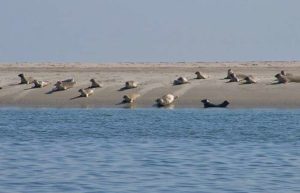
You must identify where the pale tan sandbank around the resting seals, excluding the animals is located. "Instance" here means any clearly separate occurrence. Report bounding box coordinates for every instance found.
[0,62,300,108]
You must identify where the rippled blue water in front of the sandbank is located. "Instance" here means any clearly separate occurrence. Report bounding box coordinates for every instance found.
[0,108,300,193]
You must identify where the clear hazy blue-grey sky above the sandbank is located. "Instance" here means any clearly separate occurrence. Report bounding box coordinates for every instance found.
[0,0,300,62]
